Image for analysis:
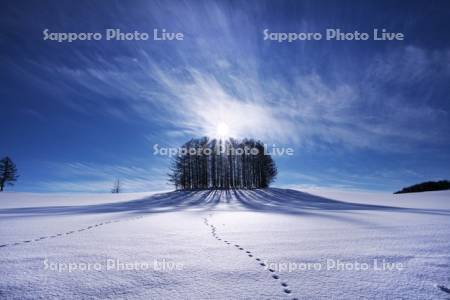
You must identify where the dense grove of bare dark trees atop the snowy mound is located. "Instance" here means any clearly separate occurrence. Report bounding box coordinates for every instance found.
[169,137,277,190]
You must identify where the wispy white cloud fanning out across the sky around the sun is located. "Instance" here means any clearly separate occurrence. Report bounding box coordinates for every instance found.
[9,2,450,151]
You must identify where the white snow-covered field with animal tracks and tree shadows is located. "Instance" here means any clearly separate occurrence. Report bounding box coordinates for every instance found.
[0,188,450,299]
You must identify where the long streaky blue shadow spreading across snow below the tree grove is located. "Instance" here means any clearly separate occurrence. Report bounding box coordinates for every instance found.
[0,188,450,218]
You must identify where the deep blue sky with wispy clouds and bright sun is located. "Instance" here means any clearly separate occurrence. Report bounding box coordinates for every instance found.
[0,1,450,192]
